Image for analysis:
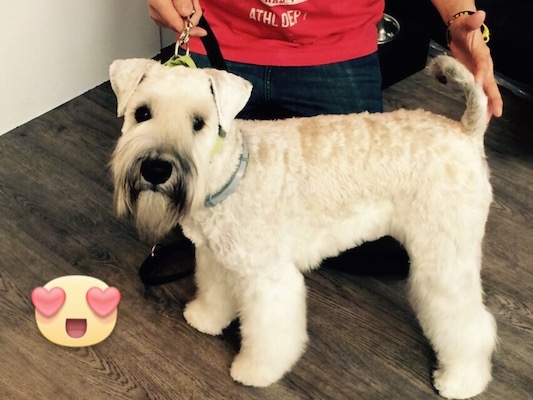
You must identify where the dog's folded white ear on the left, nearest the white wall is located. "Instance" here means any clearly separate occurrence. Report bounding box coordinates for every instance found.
[109,58,159,117]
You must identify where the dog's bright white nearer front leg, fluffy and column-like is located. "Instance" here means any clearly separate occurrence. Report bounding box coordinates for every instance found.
[231,263,307,386]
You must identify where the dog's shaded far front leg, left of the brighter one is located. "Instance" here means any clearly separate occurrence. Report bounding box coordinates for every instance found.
[183,246,237,335]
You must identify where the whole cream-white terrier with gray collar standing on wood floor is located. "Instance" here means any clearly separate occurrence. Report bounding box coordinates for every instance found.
[110,56,497,399]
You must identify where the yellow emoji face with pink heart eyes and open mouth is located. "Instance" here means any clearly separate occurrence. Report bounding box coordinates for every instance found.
[31,275,120,347]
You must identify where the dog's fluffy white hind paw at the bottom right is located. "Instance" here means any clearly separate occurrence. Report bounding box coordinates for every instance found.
[433,364,491,399]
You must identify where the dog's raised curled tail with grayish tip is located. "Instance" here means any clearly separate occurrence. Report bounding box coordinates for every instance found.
[428,56,488,137]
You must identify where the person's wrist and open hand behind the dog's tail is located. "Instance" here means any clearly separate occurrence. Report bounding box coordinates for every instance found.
[431,0,503,117]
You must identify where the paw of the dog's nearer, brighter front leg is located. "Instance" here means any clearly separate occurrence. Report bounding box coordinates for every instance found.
[230,353,286,387]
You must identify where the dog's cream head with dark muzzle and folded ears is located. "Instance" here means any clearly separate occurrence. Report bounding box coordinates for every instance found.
[110,59,251,241]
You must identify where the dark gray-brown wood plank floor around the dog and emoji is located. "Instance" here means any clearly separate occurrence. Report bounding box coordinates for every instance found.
[0,54,533,400]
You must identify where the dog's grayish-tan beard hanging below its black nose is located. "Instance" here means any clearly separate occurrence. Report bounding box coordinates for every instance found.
[134,190,179,243]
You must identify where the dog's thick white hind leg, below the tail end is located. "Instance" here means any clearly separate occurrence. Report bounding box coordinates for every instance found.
[409,228,497,399]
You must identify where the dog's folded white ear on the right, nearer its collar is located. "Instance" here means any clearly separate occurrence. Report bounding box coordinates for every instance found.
[204,68,252,132]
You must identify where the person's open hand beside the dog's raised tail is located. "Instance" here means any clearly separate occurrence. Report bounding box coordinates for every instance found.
[449,11,503,119]
